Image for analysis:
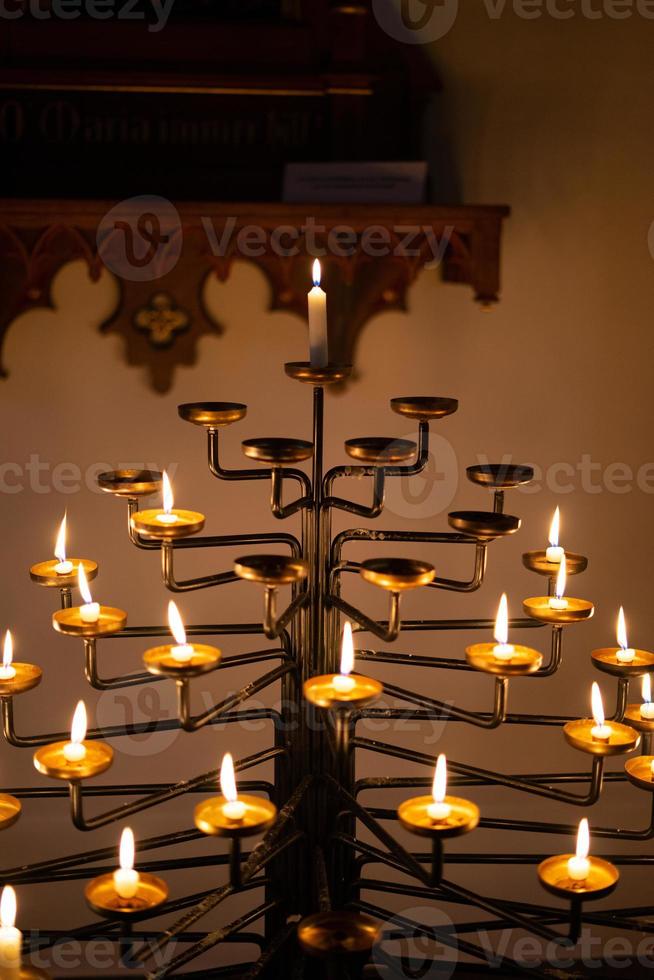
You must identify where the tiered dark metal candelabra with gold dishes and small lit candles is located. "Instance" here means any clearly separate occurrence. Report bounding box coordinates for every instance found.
[0,363,654,978]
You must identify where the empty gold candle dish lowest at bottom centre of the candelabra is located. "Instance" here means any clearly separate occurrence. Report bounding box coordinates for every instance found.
[297,911,380,957]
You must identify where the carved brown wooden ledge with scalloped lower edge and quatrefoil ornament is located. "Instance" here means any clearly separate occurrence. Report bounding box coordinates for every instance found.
[0,198,509,392]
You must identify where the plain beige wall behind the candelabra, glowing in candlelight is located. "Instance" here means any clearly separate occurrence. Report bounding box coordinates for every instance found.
[0,4,654,972]
